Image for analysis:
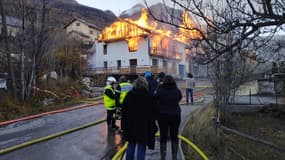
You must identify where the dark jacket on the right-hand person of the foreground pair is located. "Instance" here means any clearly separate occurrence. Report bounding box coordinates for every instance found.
[155,85,182,116]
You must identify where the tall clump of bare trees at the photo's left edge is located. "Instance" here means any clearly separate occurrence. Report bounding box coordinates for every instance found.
[1,0,50,101]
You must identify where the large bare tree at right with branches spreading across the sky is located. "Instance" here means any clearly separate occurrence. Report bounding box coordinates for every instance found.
[144,0,285,121]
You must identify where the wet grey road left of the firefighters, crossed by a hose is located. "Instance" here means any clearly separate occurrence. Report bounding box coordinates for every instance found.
[0,105,121,160]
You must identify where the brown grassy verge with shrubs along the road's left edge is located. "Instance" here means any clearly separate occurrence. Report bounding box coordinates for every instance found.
[0,77,90,121]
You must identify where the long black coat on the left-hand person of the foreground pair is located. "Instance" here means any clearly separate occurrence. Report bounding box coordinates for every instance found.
[122,89,157,149]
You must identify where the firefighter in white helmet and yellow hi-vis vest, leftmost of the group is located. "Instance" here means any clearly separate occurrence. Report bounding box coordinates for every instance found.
[103,77,118,129]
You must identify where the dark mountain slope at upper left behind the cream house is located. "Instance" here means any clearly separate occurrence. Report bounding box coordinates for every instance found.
[4,0,117,29]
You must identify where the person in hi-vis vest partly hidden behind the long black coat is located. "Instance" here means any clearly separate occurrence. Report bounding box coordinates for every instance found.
[115,76,133,133]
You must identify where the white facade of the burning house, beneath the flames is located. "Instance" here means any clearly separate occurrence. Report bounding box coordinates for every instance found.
[92,36,189,78]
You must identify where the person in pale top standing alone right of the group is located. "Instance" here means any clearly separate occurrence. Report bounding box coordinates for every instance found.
[185,73,195,105]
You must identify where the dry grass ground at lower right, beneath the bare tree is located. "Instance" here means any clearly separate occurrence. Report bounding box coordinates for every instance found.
[182,105,285,160]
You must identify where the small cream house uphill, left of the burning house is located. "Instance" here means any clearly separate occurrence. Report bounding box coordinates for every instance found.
[64,18,100,44]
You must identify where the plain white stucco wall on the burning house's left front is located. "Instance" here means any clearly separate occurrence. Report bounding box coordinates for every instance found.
[95,38,151,68]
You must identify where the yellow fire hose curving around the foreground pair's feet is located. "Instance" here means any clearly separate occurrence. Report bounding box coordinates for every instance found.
[112,133,208,160]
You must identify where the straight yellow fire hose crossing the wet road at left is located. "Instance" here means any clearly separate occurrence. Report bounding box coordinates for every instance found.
[0,119,106,155]
